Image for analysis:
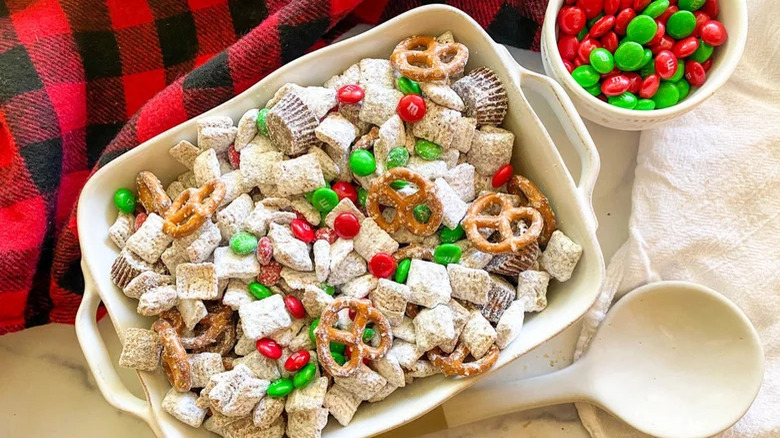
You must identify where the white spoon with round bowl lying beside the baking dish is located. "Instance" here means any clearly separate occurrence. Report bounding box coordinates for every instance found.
[445,282,764,438]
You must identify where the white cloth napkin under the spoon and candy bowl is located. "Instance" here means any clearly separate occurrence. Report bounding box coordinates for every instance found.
[575,0,780,438]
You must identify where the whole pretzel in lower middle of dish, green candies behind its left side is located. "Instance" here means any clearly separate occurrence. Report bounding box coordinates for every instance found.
[314,296,393,377]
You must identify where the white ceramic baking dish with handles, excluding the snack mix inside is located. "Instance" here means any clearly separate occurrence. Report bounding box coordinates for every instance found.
[76,5,604,438]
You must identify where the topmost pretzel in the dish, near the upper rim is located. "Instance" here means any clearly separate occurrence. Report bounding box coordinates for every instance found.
[390,35,469,82]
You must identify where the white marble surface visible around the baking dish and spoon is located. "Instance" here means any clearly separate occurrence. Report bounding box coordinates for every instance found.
[0,45,639,438]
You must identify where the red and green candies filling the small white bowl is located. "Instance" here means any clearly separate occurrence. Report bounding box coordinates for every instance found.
[558,0,727,111]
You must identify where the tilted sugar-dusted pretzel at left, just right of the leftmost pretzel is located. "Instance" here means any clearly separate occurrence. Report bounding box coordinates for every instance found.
[163,179,226,237]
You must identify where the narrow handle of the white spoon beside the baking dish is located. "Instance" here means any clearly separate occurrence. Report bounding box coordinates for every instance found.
[442,362,590,427]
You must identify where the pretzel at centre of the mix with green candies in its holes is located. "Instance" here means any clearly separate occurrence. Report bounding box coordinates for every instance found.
[366,167,443,236]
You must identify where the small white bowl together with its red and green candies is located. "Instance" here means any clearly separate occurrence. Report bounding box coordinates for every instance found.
[541,0,747,130]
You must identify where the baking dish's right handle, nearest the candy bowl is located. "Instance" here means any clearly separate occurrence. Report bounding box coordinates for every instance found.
[520,67,600,228]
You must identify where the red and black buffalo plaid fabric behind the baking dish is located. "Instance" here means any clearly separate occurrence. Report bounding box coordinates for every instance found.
[0,0,547,334]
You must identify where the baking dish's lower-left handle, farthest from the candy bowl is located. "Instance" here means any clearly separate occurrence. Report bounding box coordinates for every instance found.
[76,269,151,423]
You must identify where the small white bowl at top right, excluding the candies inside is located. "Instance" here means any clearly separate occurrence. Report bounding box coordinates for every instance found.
[541,0,748,131]
